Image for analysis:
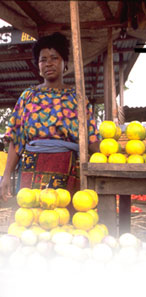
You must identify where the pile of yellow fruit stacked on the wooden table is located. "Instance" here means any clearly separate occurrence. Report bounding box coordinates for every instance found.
[89,121,146,163]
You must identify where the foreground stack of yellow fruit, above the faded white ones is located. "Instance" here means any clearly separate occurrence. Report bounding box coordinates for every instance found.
[8,188,108,246]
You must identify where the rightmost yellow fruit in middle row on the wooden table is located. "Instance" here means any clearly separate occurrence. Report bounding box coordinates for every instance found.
[125,140,145,155]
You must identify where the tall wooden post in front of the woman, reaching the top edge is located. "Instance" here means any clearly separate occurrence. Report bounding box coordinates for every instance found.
[70,1,88,189]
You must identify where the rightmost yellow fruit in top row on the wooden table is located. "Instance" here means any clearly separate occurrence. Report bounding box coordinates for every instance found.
[125,121,146,140]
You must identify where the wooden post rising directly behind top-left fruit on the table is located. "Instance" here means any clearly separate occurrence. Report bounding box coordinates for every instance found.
[107,28,117,120]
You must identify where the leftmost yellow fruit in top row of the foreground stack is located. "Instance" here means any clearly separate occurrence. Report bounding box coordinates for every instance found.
[17,188,36,208]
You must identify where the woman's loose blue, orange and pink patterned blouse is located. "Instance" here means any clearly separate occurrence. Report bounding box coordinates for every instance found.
[5,87,98,155]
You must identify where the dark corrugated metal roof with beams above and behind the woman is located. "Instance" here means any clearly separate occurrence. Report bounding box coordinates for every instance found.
[0,0,146,120]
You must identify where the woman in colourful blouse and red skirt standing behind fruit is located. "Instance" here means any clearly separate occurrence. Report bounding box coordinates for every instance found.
[0,32,98,200]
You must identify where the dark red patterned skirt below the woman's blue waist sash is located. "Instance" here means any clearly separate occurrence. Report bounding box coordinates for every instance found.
[18,151,80,195]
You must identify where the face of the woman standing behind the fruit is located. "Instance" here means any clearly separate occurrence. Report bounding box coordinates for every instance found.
[39,48,64,82]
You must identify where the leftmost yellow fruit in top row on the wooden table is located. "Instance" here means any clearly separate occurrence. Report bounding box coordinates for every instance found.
[99,121,116,138]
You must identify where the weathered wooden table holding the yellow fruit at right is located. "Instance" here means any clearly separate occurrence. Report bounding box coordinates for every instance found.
[82,163,146,236]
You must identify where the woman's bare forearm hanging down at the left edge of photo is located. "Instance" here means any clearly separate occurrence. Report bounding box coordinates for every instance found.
[0,141,19,200]
